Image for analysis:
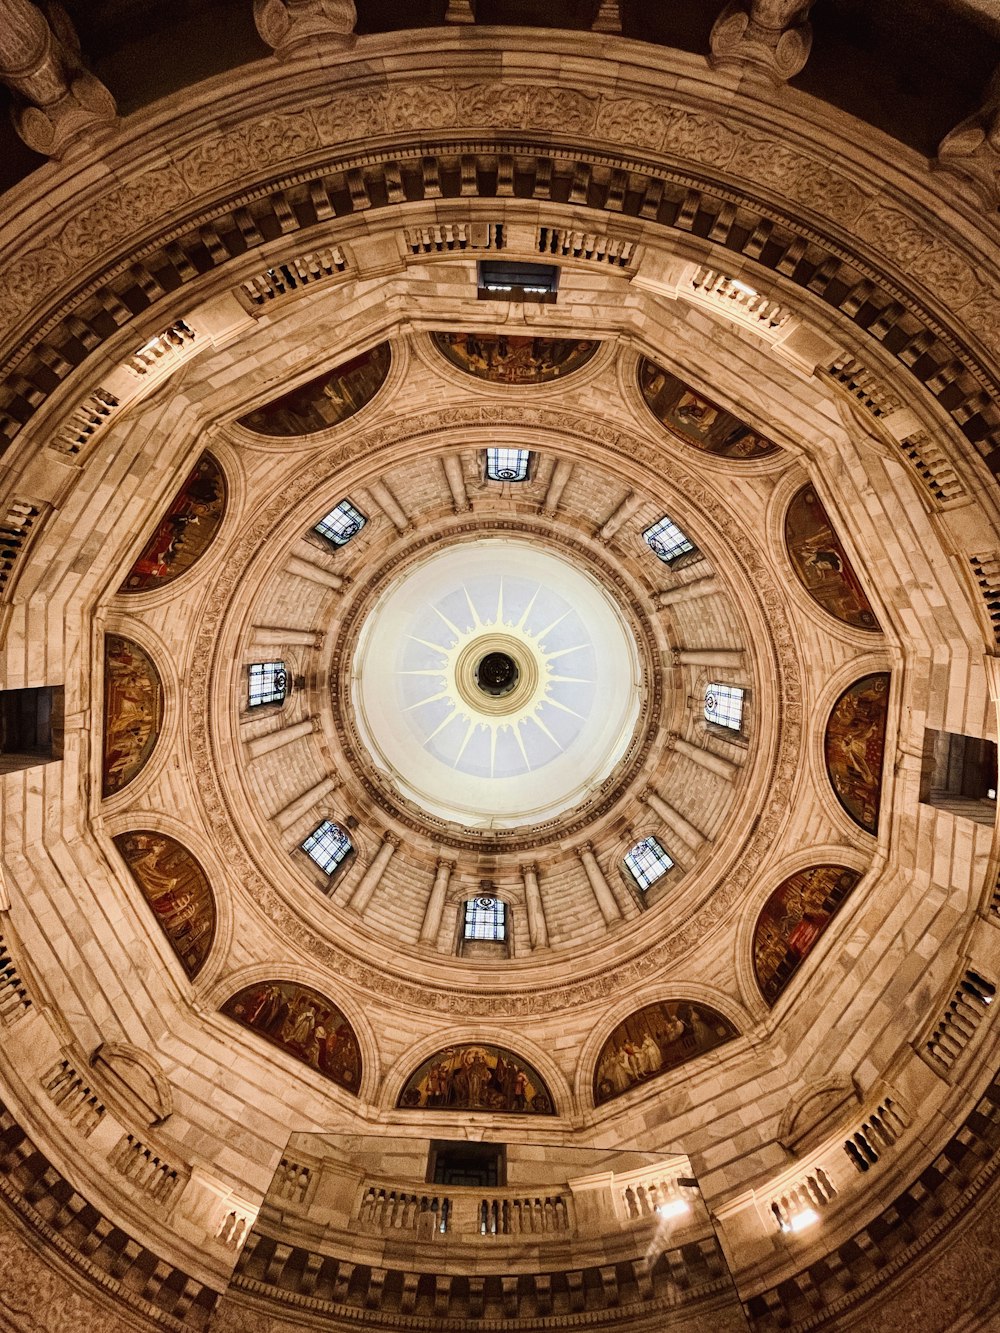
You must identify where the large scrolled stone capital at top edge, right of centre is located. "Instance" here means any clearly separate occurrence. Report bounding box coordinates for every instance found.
[709,0,812,83]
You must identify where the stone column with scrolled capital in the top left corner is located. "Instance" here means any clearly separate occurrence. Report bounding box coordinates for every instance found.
[0,0,117,157]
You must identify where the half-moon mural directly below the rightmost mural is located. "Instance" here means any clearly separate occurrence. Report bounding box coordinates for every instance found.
[753,865,861,1004]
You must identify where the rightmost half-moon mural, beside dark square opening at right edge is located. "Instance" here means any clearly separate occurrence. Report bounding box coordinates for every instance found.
[823,672,889,833]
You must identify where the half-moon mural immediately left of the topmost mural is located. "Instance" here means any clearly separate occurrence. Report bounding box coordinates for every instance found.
[239,343,392,439]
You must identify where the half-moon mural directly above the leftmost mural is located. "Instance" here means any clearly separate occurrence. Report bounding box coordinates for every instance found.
[119,453,225,592]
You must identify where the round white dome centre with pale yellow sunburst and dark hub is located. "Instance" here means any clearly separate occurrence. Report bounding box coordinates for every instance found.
[352,539,640,828]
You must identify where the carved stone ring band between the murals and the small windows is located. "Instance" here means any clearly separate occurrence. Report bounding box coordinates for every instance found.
[187,403,803,1017]
